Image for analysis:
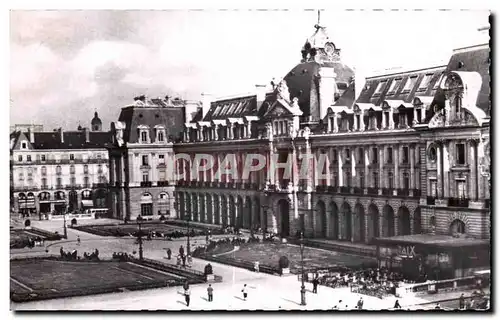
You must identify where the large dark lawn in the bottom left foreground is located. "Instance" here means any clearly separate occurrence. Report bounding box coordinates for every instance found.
[10,259,189,300]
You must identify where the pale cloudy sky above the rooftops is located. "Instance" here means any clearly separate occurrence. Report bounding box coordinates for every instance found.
[10,10,489,130]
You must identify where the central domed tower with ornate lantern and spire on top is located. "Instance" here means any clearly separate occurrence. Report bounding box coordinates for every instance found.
[284,12,354,122]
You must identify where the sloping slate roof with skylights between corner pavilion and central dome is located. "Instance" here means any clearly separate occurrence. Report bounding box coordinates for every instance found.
[203,95,257,121]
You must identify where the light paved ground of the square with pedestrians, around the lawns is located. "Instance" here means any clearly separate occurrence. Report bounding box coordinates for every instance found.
[7,220,484,310]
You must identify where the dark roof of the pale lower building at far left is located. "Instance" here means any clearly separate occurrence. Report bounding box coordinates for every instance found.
[32,131,112,149]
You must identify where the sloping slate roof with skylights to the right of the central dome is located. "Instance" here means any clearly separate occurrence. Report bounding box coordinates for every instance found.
[356,66,445,106]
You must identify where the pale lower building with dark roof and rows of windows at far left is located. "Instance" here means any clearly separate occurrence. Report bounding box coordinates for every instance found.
[10,113,111,216]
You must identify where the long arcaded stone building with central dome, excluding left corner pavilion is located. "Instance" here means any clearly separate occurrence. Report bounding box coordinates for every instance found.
[170,22,490,243]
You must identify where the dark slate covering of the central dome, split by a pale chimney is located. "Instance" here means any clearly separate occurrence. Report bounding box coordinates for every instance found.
[284,61,354,118]
